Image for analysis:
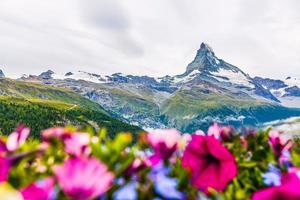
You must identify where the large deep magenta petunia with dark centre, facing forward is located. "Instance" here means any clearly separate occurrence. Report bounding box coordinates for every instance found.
[182,135,237,194]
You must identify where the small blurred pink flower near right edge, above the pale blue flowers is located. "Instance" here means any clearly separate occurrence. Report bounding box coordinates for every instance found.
[269,131,292,156]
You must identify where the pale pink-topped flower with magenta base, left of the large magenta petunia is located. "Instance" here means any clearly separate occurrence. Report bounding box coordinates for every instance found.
[147,129,180,164]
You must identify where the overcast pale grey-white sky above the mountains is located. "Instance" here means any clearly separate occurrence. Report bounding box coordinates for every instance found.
[0,0,300,78]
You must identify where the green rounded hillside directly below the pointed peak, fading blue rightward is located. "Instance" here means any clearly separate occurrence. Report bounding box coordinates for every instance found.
[162,88,300,132]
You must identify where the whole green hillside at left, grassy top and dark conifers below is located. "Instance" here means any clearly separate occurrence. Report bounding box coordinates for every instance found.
[0,78,141,137]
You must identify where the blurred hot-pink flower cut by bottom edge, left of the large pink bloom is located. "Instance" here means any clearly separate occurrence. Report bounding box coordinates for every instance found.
[21,178,55,200]
